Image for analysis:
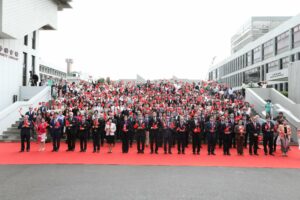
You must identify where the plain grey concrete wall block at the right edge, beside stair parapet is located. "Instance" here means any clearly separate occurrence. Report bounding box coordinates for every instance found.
[289,61,300,104]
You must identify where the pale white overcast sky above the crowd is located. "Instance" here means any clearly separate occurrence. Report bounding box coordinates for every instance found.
[40,0,300,79]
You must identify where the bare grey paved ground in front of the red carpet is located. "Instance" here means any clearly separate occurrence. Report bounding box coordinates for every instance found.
[0,165,300,200]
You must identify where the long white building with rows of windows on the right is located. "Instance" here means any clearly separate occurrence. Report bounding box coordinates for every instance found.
[208,15,300,91]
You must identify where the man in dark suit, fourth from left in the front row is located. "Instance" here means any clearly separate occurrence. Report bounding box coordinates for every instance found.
[65,112,78,151]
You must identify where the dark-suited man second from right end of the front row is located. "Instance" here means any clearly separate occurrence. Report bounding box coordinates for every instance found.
[262,115,274,156]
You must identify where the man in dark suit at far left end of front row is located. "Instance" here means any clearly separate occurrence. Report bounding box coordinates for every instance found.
[18,115,33,152]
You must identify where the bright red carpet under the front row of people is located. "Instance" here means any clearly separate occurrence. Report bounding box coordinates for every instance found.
[0,143,300,168]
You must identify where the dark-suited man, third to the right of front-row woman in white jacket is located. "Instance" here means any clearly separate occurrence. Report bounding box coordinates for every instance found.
[149,112,161,154]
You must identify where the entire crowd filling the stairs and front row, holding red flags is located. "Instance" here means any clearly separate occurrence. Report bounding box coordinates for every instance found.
[19,80,291,156]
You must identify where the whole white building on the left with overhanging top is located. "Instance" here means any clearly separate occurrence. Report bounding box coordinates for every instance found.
[0,0,71,110]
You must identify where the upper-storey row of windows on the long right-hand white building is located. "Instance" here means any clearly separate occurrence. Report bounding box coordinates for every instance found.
[214,25,300,78]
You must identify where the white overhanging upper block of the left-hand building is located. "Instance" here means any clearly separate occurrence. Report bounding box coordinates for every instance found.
[0,0,58,39]
